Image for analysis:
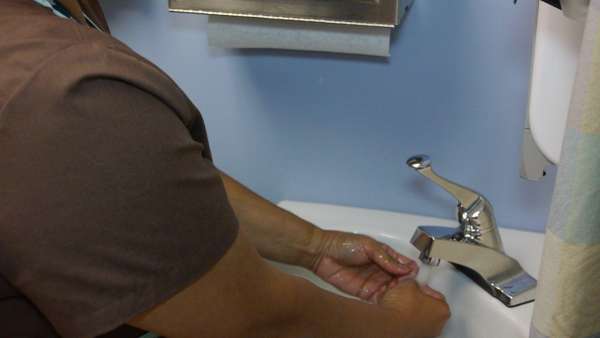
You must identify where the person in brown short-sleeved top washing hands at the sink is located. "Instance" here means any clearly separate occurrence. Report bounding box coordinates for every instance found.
[0,0,450,338]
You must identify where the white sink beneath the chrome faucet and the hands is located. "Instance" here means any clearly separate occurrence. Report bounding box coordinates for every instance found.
[272,201,544,338]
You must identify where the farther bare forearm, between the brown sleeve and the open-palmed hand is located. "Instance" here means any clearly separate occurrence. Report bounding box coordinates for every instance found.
[221,172,322,268]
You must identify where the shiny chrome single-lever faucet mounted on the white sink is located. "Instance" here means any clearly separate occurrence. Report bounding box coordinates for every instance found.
[406,155,537,307]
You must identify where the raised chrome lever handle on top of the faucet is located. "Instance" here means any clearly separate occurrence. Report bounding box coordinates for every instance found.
[406,155,483,208]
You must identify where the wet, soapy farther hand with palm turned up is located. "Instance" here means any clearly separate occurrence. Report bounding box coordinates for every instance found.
[311,231,418,302]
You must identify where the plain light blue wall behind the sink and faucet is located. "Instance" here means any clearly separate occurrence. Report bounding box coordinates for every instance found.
[102,0,555,231]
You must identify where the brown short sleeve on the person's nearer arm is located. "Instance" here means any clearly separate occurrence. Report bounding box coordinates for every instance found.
[0,44,238,338]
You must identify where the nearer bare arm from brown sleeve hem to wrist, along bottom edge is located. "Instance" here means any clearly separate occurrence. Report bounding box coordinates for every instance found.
[130,234,411,338]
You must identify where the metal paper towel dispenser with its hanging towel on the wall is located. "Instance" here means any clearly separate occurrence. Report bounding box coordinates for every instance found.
[169,0,414,56]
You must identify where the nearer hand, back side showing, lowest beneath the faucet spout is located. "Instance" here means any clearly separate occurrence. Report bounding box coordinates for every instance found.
[375,278,450,338]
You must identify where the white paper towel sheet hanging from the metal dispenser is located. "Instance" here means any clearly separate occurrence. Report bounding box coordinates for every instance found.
[208,15,392,57]
